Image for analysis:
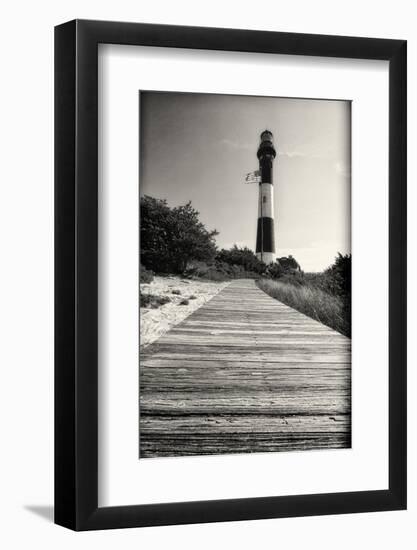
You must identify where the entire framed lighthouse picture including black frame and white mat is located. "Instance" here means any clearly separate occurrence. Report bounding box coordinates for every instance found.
[55,20,406,530]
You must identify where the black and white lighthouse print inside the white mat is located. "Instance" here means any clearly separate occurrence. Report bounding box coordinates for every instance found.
[138,91,352,459]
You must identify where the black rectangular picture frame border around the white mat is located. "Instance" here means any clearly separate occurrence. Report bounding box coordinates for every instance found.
[55,20,407,531]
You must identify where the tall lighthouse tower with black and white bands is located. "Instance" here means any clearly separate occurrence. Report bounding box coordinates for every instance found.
[256,130,277,264]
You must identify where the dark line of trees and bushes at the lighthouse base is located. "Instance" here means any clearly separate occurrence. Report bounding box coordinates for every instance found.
[140,195,351,292]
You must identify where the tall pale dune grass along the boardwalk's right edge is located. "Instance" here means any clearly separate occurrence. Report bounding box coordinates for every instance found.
[257,279,350,337]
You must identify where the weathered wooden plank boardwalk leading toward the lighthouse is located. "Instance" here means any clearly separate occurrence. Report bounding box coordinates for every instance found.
[140,279,351,458]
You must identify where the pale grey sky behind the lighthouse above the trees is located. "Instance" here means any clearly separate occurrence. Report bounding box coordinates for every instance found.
[139,92,351,271]
